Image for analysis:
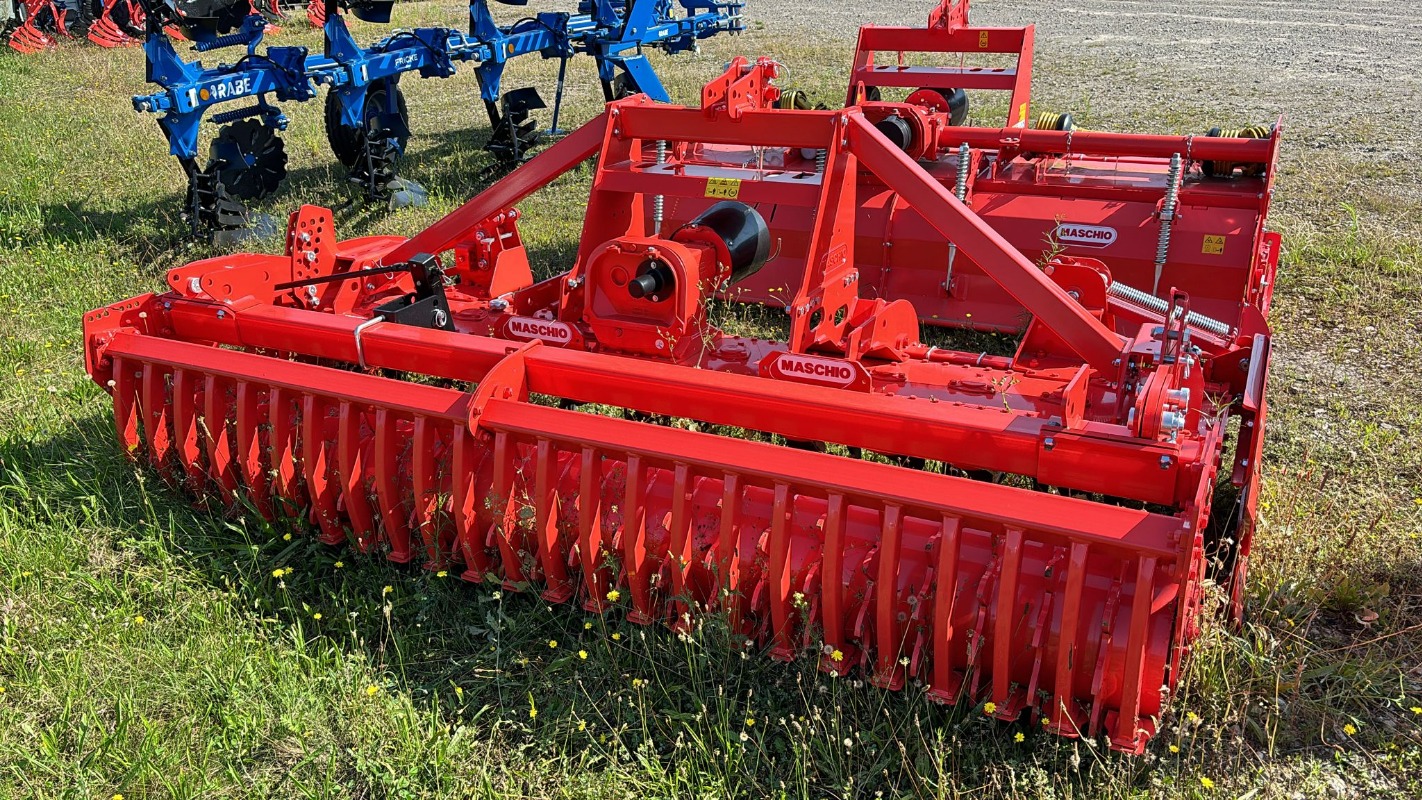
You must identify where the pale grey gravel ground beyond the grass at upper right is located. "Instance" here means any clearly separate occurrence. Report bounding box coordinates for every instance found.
[767,0,1422,118]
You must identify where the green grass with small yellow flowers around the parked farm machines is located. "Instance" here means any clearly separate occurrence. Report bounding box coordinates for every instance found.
[0,3,1422,800]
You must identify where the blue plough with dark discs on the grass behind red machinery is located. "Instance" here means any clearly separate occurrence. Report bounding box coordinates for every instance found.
[134,0,744,232]
